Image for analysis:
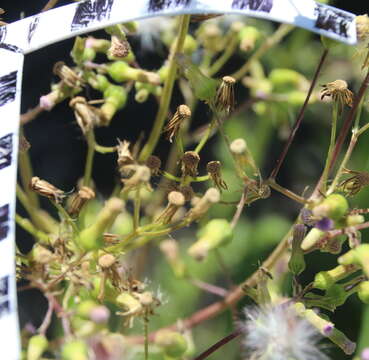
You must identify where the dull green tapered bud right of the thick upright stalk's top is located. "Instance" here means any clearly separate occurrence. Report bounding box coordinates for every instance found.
[176,54,218,101]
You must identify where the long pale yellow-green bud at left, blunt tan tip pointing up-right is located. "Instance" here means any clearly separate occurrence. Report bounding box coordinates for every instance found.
[78,198,124,251]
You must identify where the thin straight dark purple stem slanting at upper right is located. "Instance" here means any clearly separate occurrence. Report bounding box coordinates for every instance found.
[269,49,328,179]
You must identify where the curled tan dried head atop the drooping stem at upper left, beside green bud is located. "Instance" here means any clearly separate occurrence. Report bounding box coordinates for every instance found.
[69,96,100,134]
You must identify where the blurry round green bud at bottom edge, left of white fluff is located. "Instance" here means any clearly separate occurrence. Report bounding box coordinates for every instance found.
[155,330,187,359]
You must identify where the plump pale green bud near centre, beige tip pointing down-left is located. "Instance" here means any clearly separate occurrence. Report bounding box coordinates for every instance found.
[188,219,233,261]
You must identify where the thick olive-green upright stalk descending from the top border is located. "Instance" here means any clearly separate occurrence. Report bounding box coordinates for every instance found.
[139,15,191,161]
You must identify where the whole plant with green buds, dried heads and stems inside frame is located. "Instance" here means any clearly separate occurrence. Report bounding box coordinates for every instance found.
[7,0,369,360]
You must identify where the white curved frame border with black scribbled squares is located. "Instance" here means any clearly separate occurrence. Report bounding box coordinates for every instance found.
[0,0,356,360]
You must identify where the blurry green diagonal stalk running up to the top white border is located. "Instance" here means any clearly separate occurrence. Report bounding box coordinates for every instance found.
[231,24,293,80]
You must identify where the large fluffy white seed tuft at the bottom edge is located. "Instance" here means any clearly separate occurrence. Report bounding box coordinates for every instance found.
[240,305,329,360]
